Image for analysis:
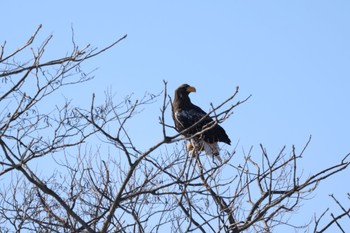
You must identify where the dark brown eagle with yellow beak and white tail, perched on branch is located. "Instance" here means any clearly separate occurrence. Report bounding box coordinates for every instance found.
[172,84,231,161]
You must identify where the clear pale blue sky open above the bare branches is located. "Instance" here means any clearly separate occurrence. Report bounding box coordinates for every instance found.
[0,0,350,229]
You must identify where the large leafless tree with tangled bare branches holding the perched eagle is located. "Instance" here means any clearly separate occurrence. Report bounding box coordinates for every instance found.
[0,27,349,233]
